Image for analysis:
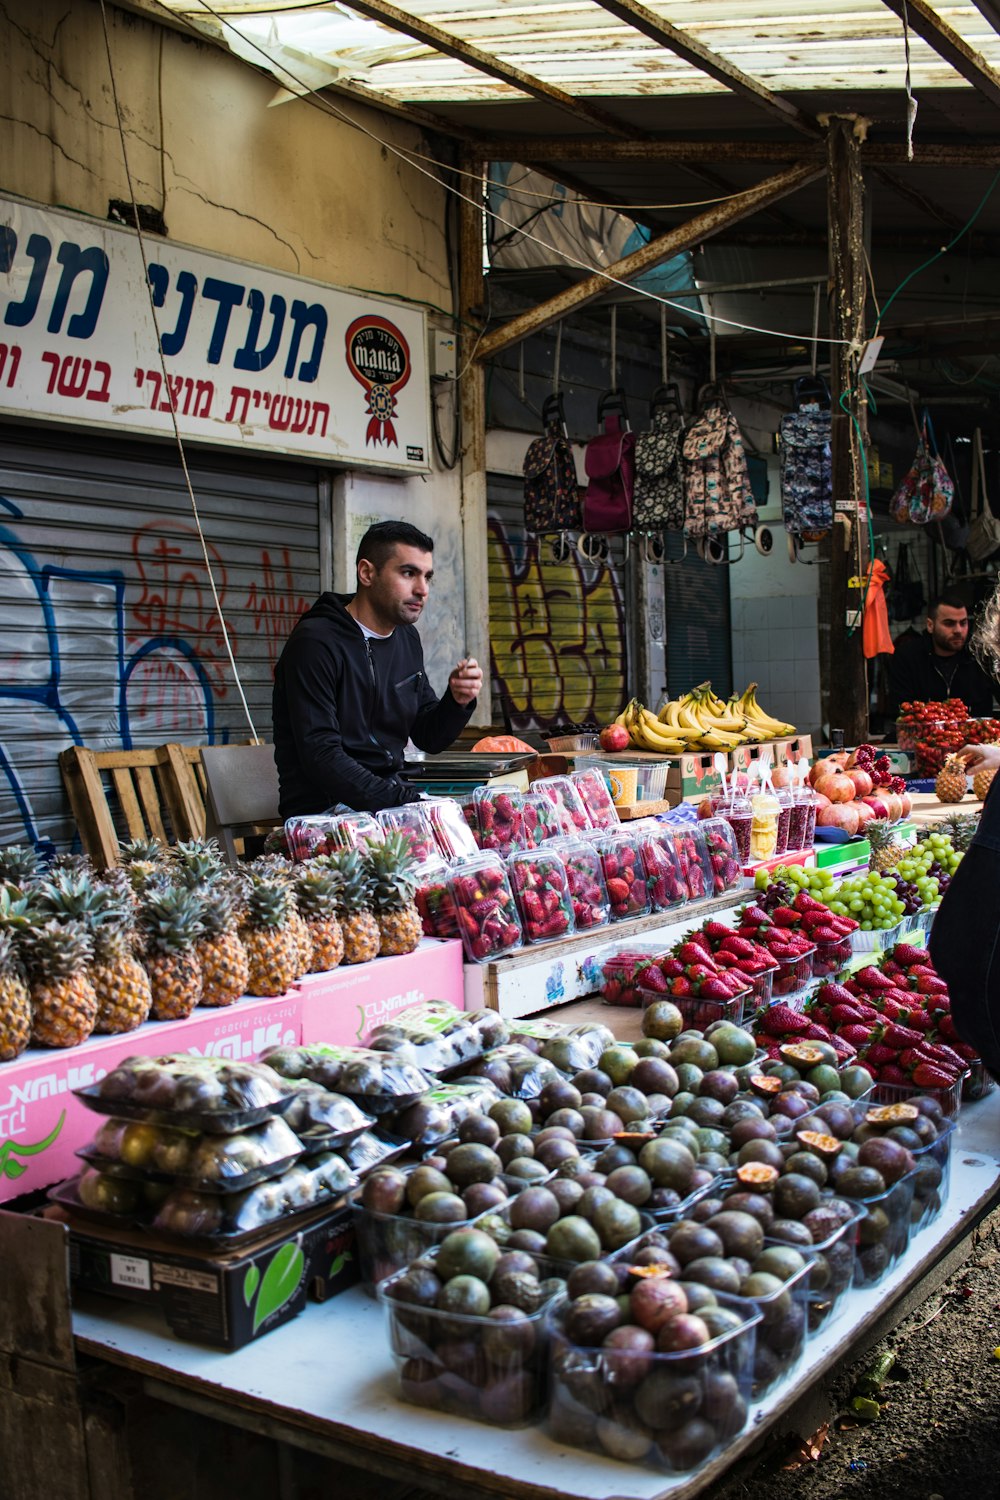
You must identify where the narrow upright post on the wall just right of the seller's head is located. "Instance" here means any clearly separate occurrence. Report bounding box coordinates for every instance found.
[459,159,492,728]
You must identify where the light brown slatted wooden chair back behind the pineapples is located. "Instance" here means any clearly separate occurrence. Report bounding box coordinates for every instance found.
[58,744,205,870]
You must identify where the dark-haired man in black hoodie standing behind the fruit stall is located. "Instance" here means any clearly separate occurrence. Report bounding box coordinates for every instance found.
[273,521,483,818]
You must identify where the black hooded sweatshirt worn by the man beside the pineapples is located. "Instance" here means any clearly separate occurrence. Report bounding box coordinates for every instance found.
[273,594,475,818]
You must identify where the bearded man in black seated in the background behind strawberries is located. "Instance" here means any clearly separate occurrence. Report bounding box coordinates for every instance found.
[885,594,997,719]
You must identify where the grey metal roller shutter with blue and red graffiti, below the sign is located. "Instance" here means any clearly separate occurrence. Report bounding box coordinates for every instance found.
[0,426,327,848]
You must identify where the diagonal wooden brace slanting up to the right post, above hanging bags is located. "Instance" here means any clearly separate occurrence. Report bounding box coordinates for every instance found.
[475,162,826,360]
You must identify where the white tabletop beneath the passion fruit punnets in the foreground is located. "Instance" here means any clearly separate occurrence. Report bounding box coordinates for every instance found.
[72,1062,1000,1500]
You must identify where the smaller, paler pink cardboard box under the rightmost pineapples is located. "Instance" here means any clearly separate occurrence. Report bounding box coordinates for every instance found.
[298,938,465,1047]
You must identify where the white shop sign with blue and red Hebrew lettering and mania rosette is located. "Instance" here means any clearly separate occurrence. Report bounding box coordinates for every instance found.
[0,195,429,471]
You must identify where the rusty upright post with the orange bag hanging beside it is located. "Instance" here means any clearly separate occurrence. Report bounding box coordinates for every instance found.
[820,117,870,744]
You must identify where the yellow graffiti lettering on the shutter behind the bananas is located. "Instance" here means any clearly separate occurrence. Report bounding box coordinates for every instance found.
[489,521,625,729]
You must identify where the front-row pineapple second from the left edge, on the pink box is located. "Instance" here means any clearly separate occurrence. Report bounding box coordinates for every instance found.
[24,921,97,1047]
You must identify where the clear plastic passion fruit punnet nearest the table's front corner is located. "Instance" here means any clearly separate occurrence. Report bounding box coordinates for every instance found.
[549,1292,760,1473]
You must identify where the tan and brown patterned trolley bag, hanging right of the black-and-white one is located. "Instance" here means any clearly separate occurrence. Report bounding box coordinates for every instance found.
[684,393,757,539]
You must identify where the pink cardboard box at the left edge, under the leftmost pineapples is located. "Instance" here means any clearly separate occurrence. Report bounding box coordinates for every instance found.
[0,990,301,1203]
